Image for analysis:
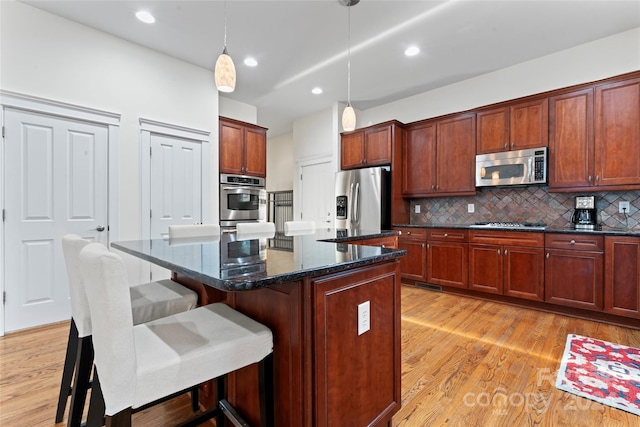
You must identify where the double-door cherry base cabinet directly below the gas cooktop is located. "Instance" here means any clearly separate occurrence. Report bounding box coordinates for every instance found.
[469,230,544,301]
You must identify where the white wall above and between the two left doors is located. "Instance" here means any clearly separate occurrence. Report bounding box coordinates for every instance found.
[0,1,218,240]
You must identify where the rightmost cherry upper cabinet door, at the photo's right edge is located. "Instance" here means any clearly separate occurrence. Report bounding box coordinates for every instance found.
[595,78,640,186]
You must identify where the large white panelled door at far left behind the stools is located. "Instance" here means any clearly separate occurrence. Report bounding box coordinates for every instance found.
[4,109,108,332]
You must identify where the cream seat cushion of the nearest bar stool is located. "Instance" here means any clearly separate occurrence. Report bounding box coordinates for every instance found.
[131,303,273,413]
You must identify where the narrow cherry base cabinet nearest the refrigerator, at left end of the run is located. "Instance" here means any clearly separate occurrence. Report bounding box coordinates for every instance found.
[394,227,427,282]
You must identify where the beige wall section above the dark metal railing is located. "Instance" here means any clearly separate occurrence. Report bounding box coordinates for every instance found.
[267,133,295,191]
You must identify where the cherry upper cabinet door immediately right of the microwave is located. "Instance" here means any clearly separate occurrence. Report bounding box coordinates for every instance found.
[548,88,594,190]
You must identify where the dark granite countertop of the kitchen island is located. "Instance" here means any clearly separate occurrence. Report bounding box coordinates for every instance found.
[111,229,406,291]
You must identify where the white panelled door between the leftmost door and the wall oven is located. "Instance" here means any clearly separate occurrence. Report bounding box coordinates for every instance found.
[150,134,202,280]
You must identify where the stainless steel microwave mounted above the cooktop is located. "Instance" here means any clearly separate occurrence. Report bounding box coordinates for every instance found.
[476,147,547,187]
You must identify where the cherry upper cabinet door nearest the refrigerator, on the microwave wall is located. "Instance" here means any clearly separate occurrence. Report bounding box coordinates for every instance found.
[402,122,436,197]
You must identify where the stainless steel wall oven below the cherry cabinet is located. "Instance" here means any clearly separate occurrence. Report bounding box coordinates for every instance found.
[220,174,267,228]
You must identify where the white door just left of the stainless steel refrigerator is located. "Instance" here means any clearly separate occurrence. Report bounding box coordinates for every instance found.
[302,161,335,227]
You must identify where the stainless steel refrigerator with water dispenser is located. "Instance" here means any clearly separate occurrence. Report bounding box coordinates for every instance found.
[335,167,391,231]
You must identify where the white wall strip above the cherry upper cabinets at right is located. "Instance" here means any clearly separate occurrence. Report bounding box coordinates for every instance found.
[357,28,640,127]
